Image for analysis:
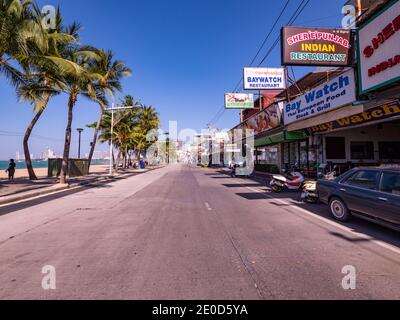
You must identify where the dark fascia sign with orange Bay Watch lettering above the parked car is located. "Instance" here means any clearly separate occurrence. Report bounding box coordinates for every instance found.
[308,101,400,134]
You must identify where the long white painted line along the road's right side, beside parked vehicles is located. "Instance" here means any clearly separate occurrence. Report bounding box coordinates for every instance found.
[238,187,400,255]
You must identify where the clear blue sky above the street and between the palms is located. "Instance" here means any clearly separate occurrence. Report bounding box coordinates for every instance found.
[0,0,345,159]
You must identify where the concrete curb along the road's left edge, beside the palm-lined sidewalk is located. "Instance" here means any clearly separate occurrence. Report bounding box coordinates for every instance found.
[0,167,163,206]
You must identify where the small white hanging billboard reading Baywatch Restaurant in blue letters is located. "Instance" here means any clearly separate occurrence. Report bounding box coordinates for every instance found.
[243,68,286,90]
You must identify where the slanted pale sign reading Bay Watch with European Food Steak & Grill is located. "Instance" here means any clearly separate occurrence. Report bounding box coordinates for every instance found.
[284,69,356,125]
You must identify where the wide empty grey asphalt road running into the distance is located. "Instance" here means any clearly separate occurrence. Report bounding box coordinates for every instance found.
[0,165,400,300]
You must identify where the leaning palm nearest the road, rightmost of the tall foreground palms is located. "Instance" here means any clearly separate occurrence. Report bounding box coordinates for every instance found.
[89,50,132,166]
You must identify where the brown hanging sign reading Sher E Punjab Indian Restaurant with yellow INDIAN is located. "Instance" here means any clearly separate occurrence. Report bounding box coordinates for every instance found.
[281,27,353,67]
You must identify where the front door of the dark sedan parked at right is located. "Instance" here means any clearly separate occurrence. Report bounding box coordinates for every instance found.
[339,170,380,216]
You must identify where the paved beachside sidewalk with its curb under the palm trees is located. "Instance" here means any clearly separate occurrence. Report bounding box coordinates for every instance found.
[0,166,160,205]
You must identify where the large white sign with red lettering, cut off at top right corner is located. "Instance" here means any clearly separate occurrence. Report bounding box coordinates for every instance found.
[358,1,400,94]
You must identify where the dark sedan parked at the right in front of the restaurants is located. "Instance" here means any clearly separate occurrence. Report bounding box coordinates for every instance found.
[317,168,400,231]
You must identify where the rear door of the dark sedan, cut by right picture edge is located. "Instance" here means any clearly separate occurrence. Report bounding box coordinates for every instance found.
[377,171,400,225]
